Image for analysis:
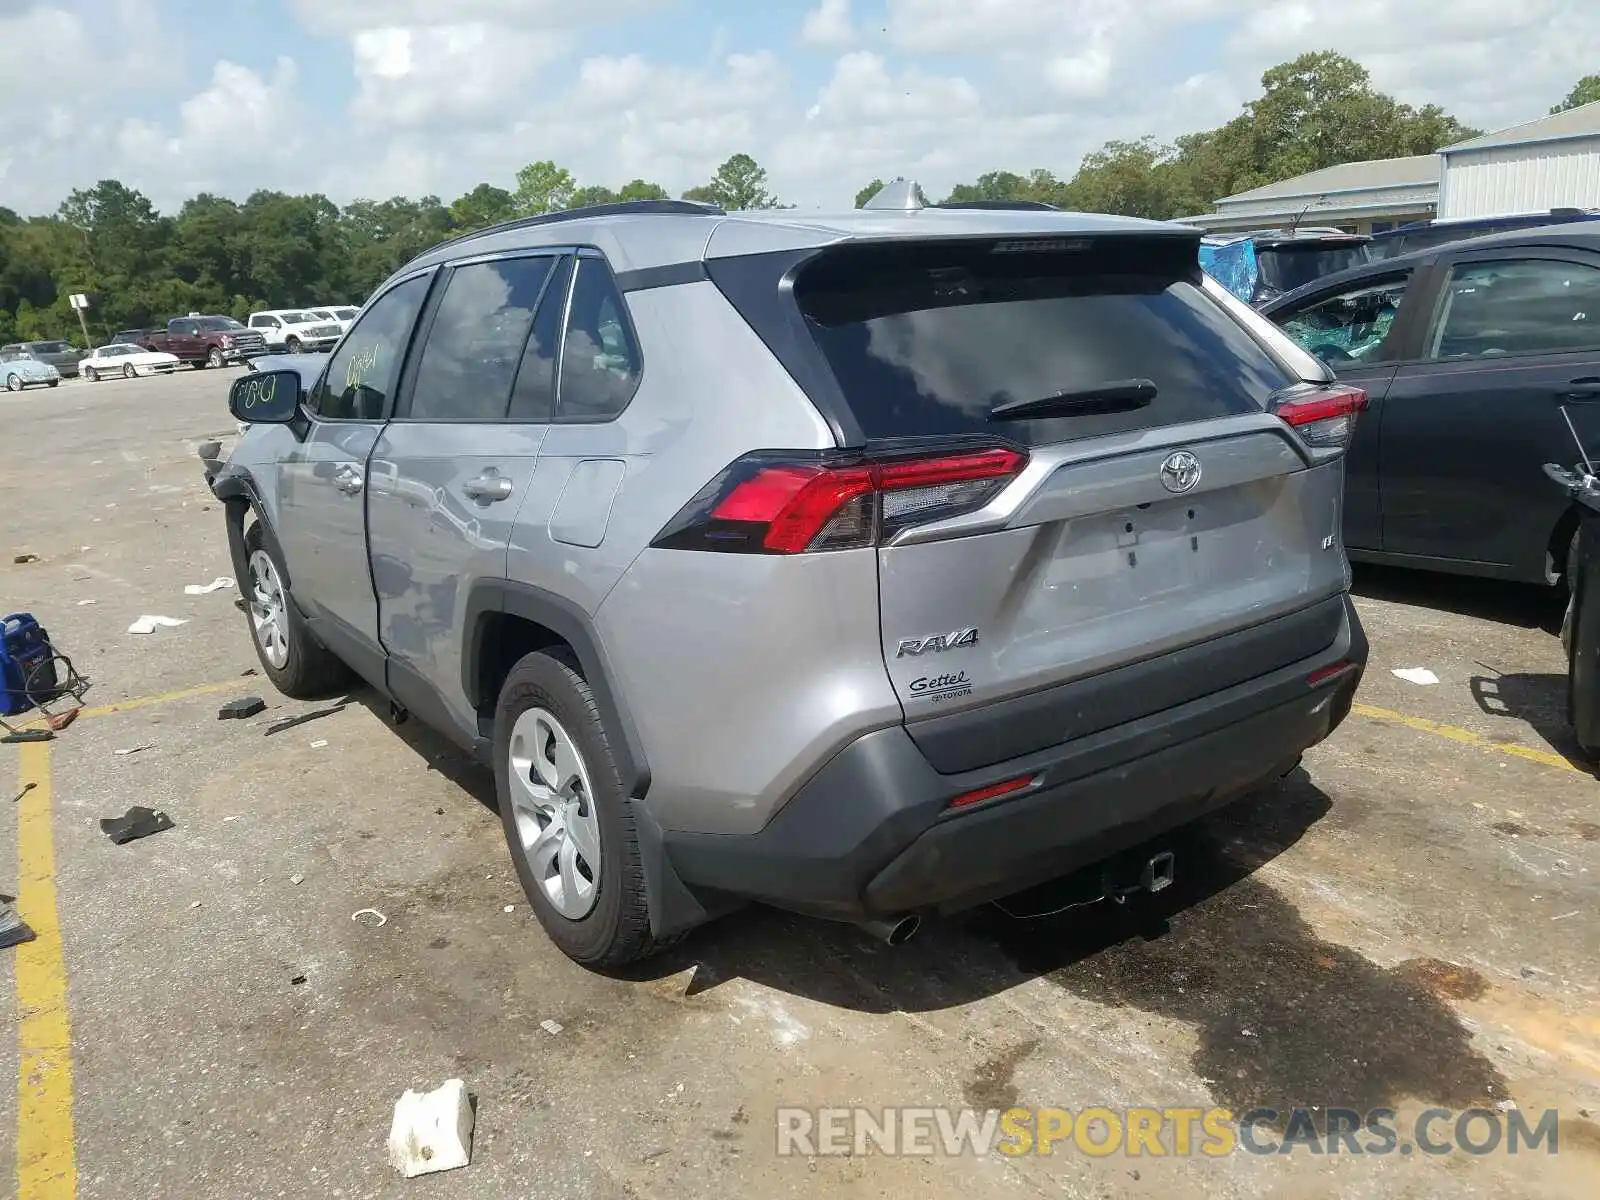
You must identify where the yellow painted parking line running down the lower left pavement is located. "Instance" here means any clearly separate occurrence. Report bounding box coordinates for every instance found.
[16,742,78,1200]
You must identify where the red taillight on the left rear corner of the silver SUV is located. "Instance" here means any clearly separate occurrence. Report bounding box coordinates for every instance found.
[653,446,1027,554]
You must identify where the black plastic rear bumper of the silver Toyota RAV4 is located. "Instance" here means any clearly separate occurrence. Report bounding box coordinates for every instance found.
[662,598,1366,920]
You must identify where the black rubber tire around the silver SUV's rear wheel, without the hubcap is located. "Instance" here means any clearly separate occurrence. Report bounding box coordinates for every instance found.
[494,646,659,968]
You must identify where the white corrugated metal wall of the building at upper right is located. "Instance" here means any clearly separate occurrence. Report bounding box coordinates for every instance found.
[1438,136,1600,218]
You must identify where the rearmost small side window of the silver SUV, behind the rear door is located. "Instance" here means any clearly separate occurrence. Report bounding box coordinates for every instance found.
[558,258,640,421]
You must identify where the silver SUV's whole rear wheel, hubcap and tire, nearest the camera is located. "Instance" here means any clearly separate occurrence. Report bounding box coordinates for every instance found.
[494,648,662,966]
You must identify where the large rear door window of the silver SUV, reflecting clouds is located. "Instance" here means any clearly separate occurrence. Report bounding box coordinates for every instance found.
[409,258,552,421]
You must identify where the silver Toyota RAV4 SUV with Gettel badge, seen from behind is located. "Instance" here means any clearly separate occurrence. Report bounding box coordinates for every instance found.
[208,195,1366,965]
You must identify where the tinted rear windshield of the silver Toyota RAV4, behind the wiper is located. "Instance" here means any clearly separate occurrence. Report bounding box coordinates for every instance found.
[795,240,1290,445]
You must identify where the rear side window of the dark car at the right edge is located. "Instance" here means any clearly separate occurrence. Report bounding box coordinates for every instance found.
[1427,259,1600,358]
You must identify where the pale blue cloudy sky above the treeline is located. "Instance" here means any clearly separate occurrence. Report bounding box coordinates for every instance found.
[0,0,1600,213]
